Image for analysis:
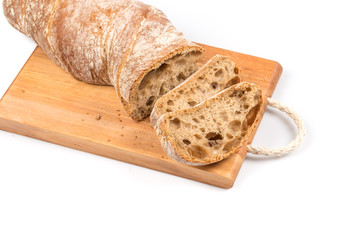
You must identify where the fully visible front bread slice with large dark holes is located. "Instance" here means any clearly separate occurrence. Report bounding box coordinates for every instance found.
[156,82,263,166]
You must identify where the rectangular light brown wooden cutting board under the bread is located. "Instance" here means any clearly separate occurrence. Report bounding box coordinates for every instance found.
[0,45,282,188]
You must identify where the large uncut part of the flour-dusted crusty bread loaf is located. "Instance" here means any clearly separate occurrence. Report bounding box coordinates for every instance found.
[3,0,203,120]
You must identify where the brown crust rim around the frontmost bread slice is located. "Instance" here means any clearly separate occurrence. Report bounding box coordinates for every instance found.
[155,82,263,166]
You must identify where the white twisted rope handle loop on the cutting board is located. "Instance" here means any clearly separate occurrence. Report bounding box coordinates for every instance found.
[247,98,306,156]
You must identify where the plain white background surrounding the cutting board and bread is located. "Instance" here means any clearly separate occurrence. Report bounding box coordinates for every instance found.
[0,0,360,240]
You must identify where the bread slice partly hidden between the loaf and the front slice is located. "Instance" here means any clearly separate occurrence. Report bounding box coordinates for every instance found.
[150,55,241,126]
